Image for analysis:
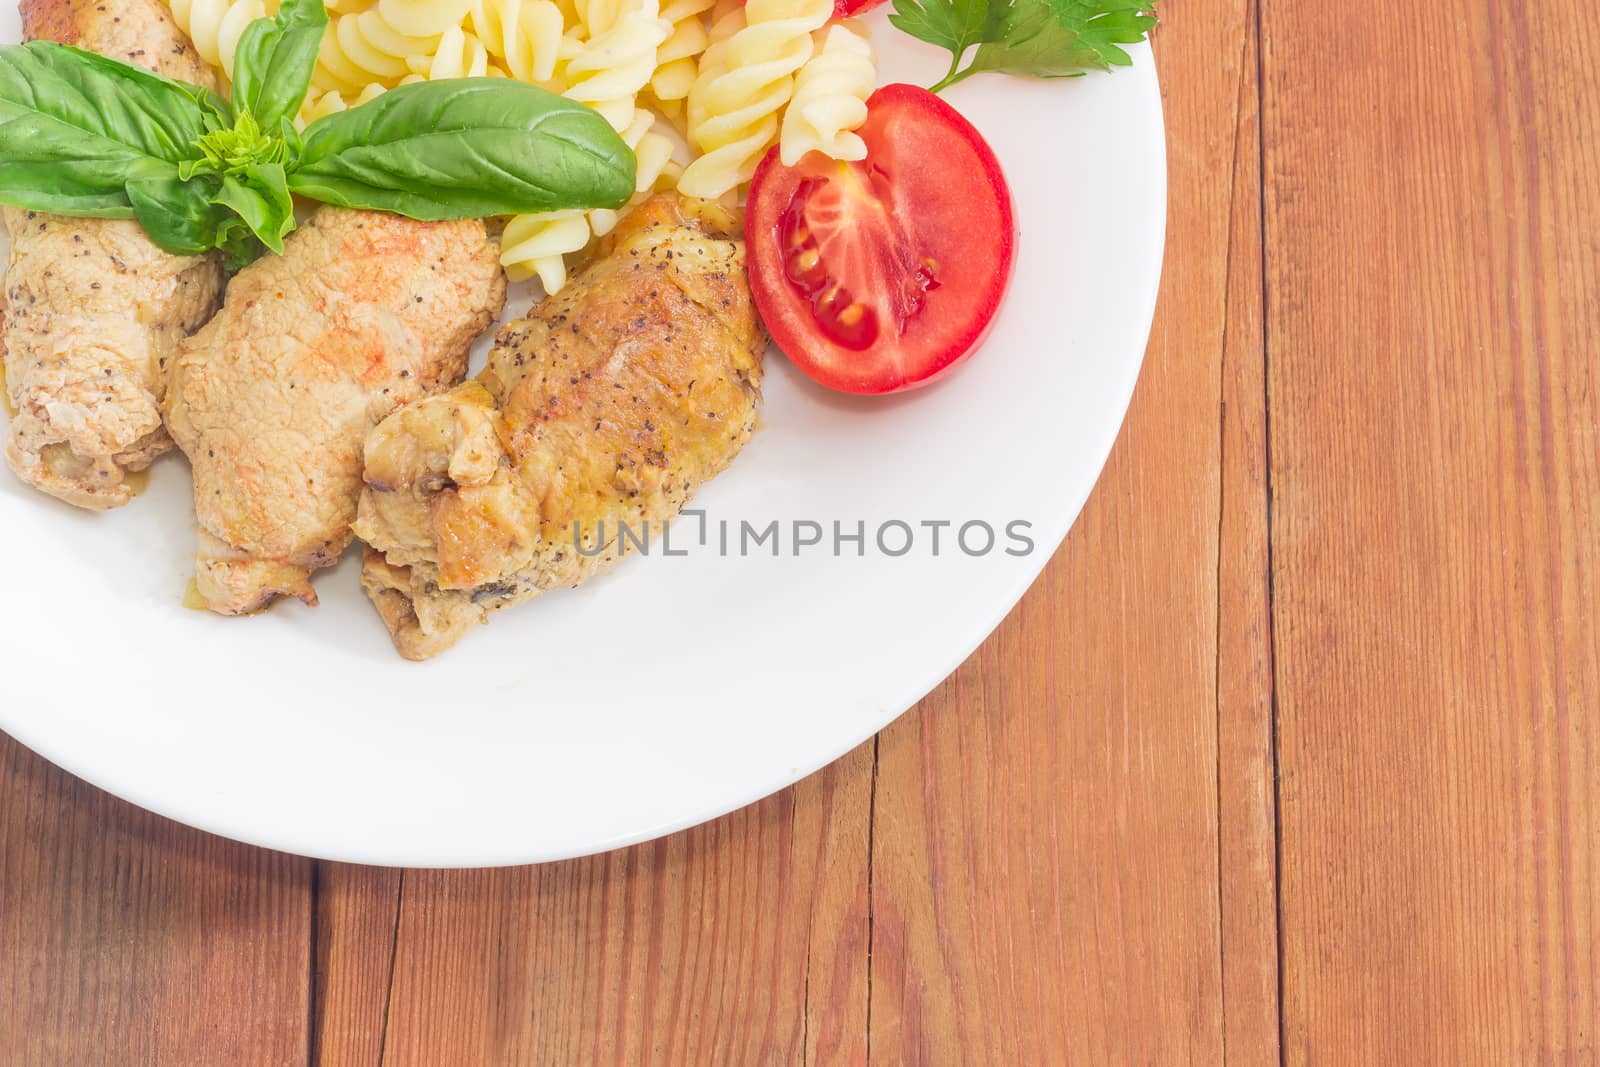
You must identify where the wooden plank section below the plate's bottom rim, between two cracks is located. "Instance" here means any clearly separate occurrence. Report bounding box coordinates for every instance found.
[364,744,872,1067]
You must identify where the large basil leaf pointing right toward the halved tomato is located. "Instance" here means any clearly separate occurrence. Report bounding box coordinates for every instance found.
[290,78,635,221]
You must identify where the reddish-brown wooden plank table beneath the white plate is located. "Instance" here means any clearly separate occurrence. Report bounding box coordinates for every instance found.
[0,0,1600,1067]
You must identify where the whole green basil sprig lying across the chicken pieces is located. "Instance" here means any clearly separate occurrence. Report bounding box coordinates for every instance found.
[0,0,635,269]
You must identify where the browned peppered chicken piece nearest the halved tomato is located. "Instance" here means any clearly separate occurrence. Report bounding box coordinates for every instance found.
[355,197,765,659]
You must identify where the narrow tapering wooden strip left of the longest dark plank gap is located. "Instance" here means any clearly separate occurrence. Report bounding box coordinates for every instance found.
[1216,5,1278,1067]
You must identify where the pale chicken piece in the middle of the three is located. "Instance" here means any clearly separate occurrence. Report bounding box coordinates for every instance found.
[166,208,506,614]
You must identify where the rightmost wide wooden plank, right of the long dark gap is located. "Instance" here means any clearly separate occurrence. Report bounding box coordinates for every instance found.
[1262,0,1600,1064]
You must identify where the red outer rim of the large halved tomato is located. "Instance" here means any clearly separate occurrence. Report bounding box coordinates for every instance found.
[746,83,1018,395]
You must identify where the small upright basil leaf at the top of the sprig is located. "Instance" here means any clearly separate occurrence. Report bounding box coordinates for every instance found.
[234,0,328,133]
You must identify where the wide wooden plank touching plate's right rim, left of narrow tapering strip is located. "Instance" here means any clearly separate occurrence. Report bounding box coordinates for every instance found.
[872,0,1275,1065]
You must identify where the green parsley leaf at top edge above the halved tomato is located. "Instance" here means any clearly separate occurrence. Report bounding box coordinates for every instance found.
[890,0,1155,93]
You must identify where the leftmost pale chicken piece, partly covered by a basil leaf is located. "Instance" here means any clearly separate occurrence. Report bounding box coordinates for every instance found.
[0,0,222,509]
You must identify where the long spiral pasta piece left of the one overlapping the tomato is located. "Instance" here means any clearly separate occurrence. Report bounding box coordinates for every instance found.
[678,0,834,200]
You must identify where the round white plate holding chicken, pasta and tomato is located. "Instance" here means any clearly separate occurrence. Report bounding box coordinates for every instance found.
[0,11,1166,865]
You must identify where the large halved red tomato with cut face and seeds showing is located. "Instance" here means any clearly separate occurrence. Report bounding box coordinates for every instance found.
[744,85,1016,394]
